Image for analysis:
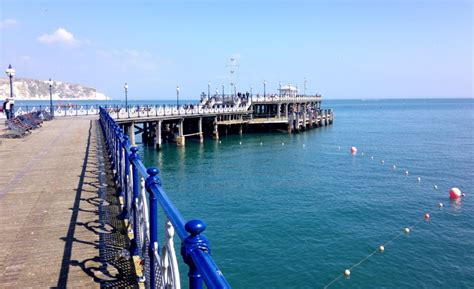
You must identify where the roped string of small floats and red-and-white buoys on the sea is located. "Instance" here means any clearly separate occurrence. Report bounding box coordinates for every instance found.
[323,146,465,289]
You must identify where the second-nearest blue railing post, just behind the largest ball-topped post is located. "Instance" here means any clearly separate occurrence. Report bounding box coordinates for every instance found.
[146,168,161,288]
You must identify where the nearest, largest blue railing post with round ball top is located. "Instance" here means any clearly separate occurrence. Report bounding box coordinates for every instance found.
[181,220,211,289]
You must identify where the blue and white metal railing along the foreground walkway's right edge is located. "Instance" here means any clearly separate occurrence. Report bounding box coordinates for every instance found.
[99,107,231,289]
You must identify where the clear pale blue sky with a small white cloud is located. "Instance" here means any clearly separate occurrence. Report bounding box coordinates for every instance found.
[0,0,474,100]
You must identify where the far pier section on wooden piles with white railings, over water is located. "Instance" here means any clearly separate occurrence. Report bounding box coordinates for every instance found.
[107,95,334,149]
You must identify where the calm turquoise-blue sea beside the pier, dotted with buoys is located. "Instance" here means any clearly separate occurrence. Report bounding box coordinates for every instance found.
[136,99,474,288]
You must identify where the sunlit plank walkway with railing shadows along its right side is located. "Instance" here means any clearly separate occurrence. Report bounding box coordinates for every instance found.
[0,117,134,288]
